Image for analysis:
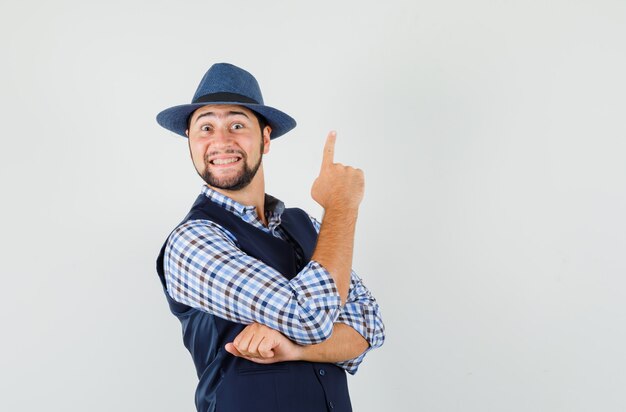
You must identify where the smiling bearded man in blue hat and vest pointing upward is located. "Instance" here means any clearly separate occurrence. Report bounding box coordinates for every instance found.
[157,63,384,412]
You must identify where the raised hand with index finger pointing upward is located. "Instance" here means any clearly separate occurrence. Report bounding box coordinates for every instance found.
[311,131,365,209]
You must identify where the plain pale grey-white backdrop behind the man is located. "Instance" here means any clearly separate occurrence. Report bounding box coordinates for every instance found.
[0,0,626,412]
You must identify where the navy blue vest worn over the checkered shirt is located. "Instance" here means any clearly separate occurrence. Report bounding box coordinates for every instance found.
[157,194,352,412]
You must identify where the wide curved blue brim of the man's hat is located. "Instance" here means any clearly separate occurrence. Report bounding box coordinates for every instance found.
[157,102,296,139]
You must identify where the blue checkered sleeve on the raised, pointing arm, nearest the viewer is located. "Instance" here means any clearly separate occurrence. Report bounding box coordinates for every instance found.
[164,220,341,345]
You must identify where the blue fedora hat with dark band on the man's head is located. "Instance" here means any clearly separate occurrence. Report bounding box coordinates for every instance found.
[157,63,296,139]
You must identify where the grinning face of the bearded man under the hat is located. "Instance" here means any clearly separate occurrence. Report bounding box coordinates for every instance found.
[187,105,271,190]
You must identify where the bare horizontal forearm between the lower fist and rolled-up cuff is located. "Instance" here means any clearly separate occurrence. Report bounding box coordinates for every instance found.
[300,323,369,363]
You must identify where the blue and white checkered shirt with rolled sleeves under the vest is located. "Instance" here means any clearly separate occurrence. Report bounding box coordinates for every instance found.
[164,185,385,374]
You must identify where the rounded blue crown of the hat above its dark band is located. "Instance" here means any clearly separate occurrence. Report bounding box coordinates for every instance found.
[192,63,264,104]
